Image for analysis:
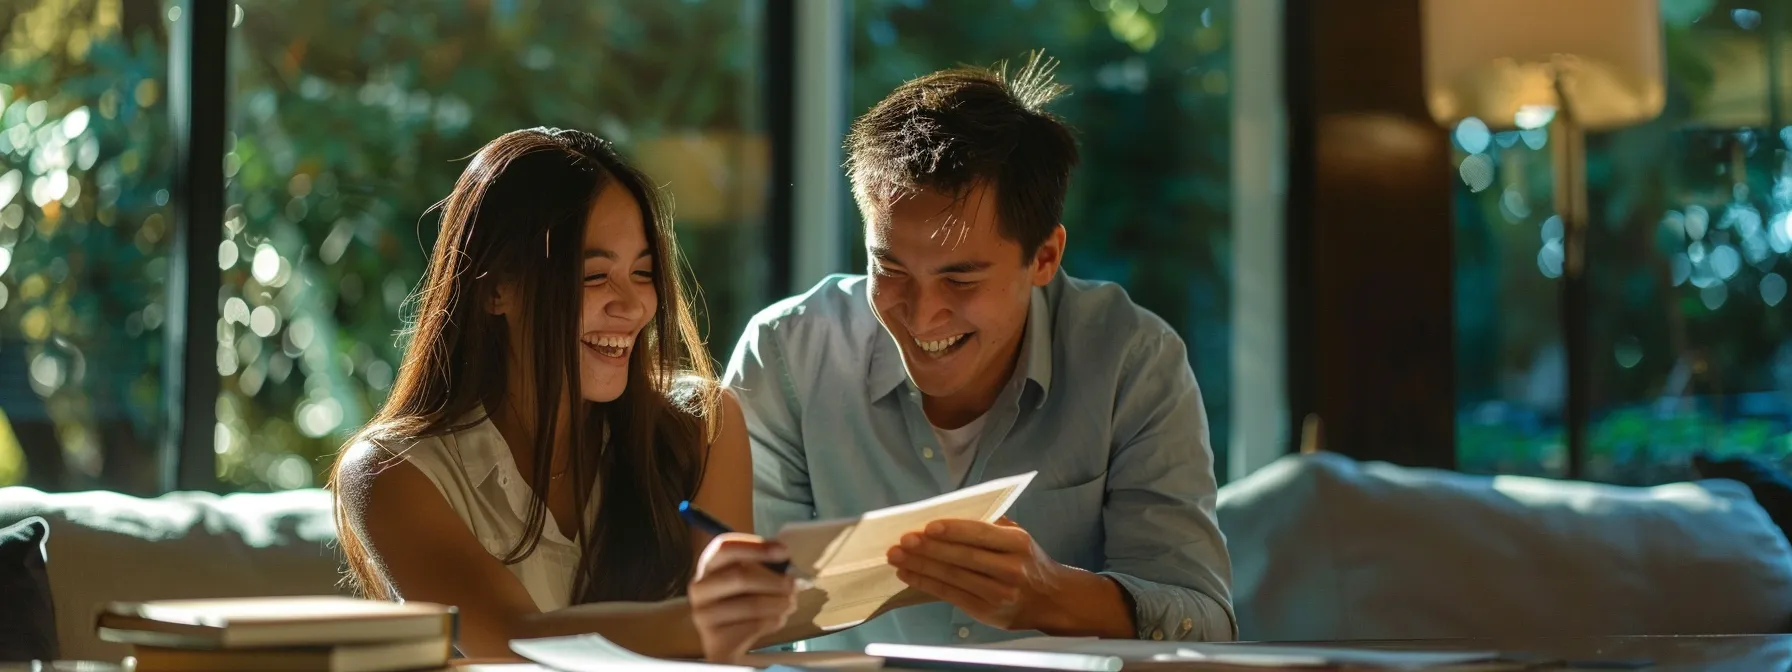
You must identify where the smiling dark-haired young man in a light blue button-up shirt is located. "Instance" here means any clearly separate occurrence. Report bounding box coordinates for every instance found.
[724,56,1236,649]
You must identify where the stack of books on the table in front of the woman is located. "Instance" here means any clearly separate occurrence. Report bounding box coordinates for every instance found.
[95,597,457,672]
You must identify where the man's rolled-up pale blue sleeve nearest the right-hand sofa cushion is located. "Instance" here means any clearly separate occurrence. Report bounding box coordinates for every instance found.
[1102,330,1238,642]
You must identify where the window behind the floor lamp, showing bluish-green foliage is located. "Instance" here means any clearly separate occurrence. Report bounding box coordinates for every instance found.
[1453,0,1792,484]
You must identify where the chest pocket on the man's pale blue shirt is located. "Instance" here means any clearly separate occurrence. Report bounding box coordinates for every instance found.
[1007,475,1107,572]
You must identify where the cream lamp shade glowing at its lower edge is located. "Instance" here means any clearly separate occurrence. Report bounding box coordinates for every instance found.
[1423,0,1667,131]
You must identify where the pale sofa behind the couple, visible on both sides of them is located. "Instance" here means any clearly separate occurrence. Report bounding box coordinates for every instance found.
[0,453,1792,659]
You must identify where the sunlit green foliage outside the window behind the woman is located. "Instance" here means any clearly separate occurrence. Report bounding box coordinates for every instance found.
[0,0,767,493]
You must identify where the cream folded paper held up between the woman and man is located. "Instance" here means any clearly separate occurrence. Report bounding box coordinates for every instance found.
[776,471,1038,631]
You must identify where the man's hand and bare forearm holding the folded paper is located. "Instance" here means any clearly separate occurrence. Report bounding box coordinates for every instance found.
[887,518,1134,638]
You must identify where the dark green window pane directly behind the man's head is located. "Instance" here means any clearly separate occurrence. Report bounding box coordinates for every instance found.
[848,0,1233,477]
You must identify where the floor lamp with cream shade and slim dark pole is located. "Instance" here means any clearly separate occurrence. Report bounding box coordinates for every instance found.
[1421,0,1667,478]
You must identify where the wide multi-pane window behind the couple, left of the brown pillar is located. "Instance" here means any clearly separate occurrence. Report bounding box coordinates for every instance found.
[0,0,1235,493]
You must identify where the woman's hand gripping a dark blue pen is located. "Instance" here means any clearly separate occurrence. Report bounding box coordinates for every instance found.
[688,534,796,663]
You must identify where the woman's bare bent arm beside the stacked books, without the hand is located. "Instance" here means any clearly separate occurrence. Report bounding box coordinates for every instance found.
[337,443,701,658]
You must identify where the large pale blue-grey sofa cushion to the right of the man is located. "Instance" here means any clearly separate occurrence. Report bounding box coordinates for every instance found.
[1219,453,1792,640]
